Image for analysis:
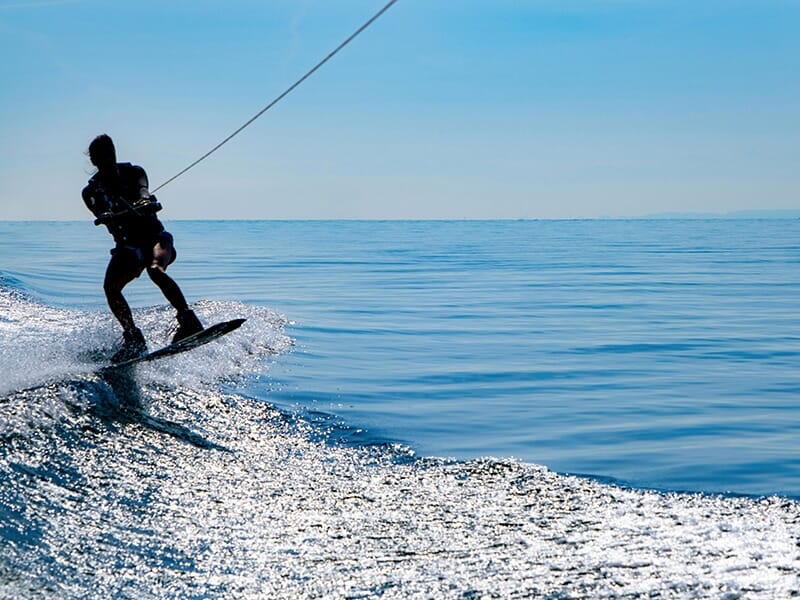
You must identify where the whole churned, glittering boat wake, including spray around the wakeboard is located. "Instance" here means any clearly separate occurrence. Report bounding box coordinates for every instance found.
[0,278,800,598]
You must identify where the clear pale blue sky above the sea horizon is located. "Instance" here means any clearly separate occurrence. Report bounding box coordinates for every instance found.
[0,0,800,220]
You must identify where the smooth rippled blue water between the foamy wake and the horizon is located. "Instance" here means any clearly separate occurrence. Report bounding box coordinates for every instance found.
[0,220,800,496]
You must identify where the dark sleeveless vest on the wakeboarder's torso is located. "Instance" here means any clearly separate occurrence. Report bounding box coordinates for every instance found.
[82,163,164,246]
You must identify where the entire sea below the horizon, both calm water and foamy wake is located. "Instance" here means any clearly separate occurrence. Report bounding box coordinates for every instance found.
[0,219,800,599]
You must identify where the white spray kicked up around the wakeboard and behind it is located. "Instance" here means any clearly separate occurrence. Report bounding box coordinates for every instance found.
[0,280,291,394]
